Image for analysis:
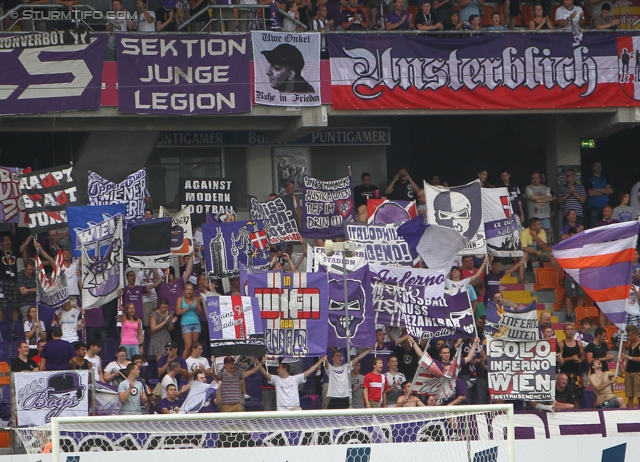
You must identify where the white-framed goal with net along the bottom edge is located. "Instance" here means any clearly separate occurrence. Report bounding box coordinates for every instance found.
[16,405,515,462]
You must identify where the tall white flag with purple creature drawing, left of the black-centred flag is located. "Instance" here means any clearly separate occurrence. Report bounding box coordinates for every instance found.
[81,215,124,309]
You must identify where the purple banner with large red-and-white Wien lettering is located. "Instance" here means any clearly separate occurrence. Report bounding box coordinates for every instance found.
[249,271,329,356]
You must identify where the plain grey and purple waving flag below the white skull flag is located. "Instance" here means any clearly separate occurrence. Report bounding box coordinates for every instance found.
[398,215,469,272]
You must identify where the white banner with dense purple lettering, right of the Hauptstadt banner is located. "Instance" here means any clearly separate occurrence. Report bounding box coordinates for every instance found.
[87,168,147,220]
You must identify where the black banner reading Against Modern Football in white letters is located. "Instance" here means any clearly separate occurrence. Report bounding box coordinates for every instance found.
[180,178,238,226]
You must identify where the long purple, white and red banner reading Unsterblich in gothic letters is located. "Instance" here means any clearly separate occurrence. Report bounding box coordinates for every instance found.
[327,33,640,109]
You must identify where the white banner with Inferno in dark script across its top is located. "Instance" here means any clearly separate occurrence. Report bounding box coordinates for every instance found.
[369,265,445,327]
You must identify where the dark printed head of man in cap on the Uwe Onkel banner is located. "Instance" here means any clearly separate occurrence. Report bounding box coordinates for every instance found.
[262,43,315,93]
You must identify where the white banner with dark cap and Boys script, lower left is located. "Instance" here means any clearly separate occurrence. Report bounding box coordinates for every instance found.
[12,370,89,427]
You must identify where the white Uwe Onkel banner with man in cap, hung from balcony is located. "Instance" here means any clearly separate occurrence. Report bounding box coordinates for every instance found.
[251,31,321,107]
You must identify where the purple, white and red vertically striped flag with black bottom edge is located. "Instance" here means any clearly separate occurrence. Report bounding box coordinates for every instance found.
[205,296,264,356]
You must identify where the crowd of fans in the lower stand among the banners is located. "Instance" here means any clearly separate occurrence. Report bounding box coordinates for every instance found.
[5,162,640,414]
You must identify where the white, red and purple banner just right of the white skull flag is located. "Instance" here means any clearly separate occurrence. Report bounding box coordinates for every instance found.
[482,188,522,257]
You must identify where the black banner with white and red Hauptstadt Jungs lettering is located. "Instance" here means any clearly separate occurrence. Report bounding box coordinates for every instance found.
[18,165,78,234]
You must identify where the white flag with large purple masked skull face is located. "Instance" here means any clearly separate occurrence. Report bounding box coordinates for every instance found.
[424,180,487,255]
